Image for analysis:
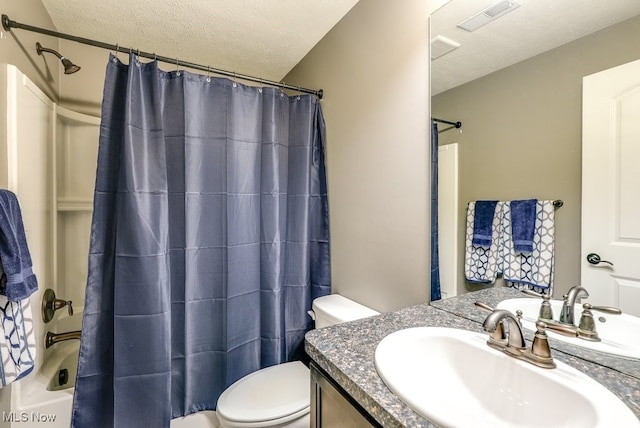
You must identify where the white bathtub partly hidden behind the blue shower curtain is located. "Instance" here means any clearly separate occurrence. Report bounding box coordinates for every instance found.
[5,313,220,428]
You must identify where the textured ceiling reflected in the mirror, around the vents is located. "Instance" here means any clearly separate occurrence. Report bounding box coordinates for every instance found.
[432,0,640,95]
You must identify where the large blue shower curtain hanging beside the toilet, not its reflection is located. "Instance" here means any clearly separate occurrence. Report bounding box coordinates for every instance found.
[73,55,330,428]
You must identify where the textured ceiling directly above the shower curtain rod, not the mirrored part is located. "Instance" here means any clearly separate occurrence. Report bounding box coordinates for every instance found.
[42,0,358,81]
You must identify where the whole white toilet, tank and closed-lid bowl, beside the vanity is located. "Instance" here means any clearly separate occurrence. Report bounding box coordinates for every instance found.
[216,294,379,428]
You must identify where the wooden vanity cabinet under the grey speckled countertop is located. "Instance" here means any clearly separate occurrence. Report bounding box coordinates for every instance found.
[310,362,380,428]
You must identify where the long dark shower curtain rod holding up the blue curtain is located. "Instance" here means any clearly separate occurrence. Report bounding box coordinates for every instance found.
[2,14,324,99]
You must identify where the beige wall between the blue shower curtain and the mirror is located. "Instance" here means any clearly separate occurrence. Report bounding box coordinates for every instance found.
[284,0,429,311]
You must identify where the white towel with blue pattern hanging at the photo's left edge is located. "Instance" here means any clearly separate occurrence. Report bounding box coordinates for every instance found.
[0,295,36,387]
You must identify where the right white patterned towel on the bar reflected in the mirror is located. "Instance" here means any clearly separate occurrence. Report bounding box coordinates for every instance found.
[500,201,555,295]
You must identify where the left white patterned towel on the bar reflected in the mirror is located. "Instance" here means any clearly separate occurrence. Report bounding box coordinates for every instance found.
[464,201,505,284]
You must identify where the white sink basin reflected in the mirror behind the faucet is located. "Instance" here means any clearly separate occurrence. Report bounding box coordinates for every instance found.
[497,298,640,358]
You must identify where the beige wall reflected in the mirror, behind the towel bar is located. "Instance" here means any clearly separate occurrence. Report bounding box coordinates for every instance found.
[432,16,640,297]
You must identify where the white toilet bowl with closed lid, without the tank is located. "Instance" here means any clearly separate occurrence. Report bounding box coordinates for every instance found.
[216,361,310,427]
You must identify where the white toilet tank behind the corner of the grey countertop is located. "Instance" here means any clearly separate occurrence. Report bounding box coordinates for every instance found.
[309,294,380,328]
